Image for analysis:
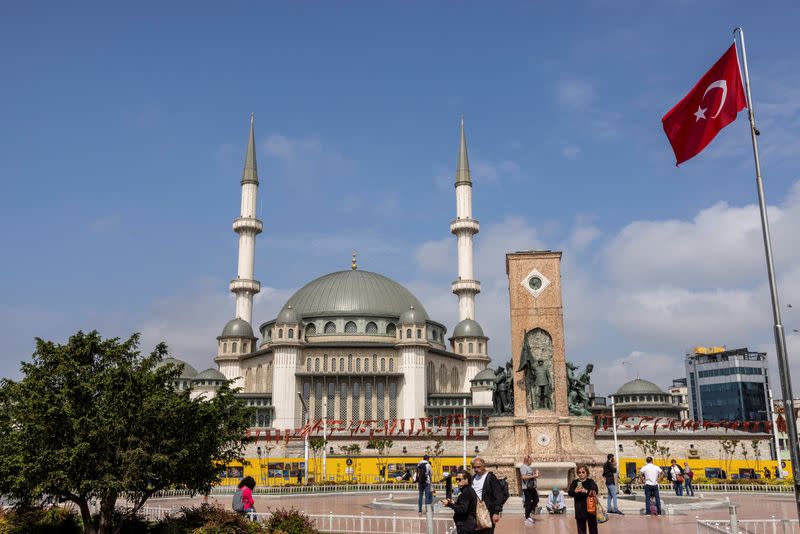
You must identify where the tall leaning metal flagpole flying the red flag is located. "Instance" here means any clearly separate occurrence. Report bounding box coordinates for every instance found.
[733,27,800,518]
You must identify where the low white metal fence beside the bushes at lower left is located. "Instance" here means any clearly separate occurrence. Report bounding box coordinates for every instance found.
[139,507,454,534]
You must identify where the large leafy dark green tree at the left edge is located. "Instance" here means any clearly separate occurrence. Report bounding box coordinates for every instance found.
[0,332,251,534]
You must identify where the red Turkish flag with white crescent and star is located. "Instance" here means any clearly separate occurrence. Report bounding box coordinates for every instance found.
[661,44,747,165]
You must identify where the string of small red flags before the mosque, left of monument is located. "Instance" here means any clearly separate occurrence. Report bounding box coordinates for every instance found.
[245,415,486,443]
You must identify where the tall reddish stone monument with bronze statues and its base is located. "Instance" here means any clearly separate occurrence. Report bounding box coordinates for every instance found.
[484,250,605,492]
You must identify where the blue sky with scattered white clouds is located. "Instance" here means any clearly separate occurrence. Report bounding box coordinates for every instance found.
[0,0,800,397]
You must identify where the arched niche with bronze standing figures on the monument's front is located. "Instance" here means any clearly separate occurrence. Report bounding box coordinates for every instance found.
[517,328,553,410]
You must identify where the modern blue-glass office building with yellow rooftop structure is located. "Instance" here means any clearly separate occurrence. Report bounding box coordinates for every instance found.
[686,347,769,421]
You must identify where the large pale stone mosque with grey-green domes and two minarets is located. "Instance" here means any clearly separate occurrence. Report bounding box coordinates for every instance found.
[174,115,494,429]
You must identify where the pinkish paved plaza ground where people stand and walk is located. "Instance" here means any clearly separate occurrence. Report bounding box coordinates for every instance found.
[148,492,795,534]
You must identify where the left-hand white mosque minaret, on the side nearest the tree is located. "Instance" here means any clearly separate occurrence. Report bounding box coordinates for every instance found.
[231,113,263,323]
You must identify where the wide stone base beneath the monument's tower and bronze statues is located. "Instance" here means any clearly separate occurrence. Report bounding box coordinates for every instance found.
[483,412,606,495]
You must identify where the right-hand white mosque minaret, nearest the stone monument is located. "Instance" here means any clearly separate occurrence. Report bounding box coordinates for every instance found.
[450,115,481,321]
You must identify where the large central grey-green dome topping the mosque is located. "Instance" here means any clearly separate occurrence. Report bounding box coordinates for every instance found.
[278,269,428,321]
